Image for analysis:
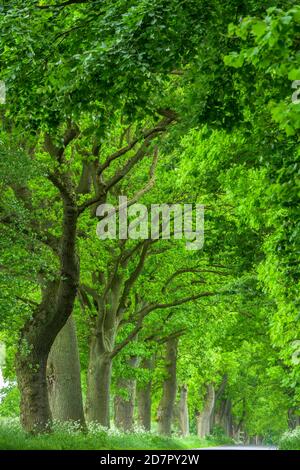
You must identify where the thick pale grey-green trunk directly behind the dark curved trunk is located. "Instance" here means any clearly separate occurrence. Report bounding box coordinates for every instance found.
[47,315,85,428]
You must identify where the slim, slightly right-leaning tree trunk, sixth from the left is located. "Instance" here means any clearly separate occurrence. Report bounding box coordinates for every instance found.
[158,338,178,435]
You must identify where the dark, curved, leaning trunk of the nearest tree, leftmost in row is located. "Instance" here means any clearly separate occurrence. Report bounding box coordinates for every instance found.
[16,202,79,433]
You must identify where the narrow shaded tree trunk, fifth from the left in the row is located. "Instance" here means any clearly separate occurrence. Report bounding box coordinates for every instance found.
[137,358,153,431]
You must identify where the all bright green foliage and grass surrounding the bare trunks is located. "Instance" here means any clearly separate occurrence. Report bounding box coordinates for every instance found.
[0,0,300,449]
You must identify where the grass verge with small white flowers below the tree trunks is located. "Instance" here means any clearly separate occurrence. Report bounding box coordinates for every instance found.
[0,419,217,450]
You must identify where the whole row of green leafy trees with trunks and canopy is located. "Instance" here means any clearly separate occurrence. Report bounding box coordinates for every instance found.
[0,0,300,436]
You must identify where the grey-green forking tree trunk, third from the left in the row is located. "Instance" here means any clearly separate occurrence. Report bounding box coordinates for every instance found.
[86,336,112,428]
